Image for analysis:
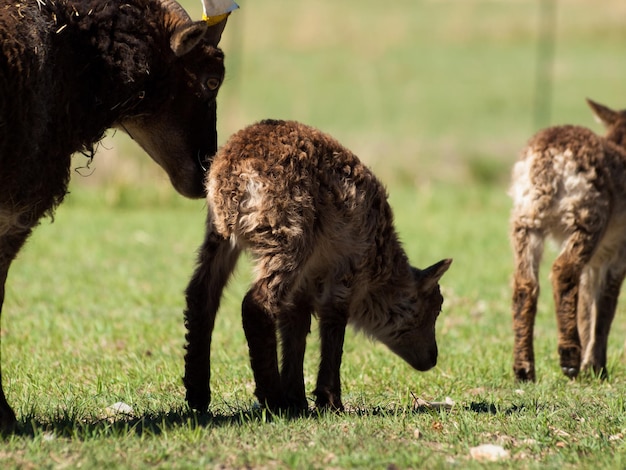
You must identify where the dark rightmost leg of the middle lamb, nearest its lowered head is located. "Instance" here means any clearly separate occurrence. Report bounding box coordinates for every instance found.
[313,308,348,411]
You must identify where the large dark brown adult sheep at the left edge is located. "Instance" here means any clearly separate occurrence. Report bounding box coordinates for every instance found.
[0,0,234,430]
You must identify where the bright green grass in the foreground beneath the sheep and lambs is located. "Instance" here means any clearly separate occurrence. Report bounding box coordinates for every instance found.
[0,183,626,468]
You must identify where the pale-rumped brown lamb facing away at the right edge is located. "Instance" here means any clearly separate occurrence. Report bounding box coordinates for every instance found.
[511,100,626,380]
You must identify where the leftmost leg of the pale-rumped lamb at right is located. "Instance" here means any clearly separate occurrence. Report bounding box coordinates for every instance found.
[511,221,544,381]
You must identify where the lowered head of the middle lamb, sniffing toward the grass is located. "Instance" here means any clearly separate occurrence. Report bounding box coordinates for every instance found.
[376,259,452,371]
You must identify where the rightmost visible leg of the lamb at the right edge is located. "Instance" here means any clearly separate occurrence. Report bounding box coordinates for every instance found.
[582,260,626,378]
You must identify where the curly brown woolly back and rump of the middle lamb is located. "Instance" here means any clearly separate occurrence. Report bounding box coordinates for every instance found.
[207,120,371,242]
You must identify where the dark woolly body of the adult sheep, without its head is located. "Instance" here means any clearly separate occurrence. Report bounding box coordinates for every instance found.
[0,0,222,222]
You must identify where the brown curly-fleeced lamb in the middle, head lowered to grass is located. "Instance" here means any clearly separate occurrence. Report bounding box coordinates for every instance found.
[184,120,451,410]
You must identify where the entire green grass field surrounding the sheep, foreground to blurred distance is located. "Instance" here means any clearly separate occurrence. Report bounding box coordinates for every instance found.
[0,0,626,468]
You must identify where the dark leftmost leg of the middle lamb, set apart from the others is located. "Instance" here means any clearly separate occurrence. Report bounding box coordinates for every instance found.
[183,227,240,411]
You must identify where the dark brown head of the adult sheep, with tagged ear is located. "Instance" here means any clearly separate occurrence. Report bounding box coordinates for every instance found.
[116,0,232,198]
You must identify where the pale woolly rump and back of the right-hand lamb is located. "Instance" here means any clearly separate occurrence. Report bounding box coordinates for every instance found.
[510,126,626,238]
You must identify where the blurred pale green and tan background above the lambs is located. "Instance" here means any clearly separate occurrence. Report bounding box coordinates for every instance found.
[73,0,626,196]
